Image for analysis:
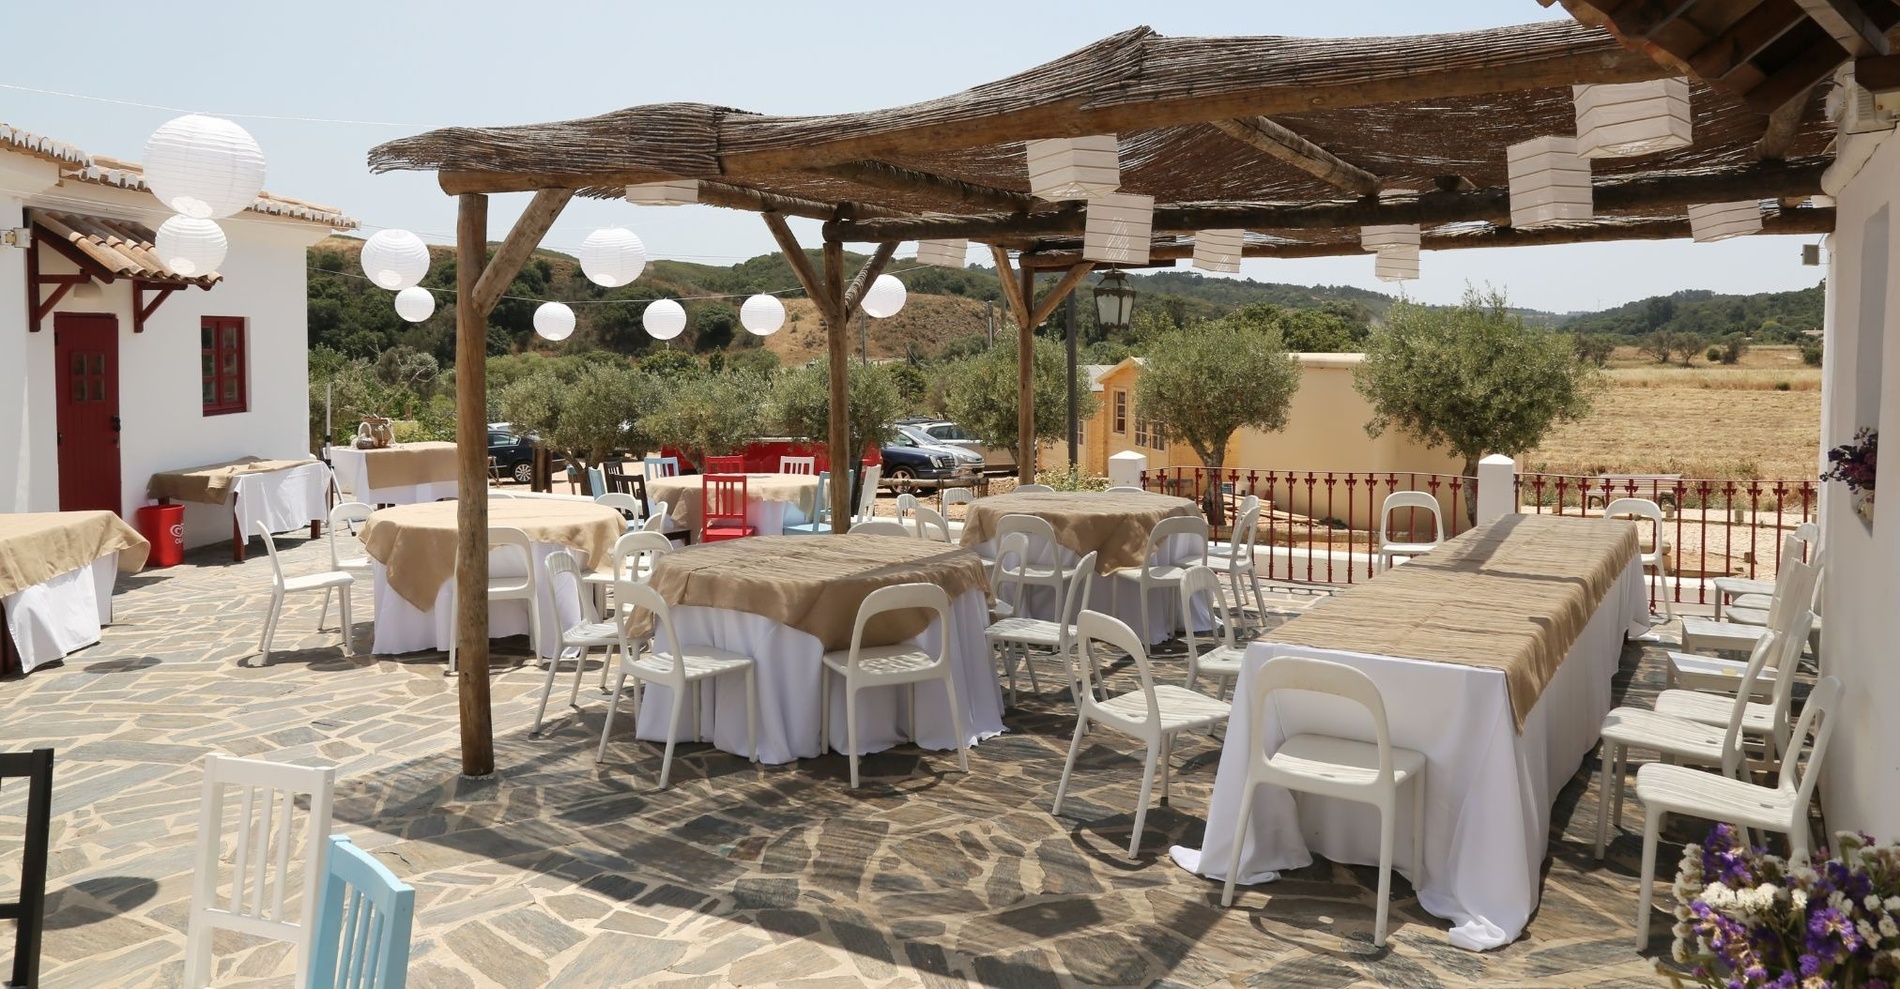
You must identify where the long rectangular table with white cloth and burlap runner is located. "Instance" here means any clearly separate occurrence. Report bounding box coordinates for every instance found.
[1172,514,1647,951]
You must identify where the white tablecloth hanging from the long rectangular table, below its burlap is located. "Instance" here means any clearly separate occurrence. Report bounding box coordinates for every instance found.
[1172,560,1649,951]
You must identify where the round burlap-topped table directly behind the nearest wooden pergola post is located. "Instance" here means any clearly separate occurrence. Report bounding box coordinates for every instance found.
[357,497,627,657]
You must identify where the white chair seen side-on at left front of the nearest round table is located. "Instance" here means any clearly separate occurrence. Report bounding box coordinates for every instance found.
[595,581,758,790]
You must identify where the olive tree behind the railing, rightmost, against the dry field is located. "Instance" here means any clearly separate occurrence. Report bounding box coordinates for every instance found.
[1353,289,1600,511]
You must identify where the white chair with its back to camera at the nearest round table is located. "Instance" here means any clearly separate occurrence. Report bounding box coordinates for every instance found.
[819,585,969,790]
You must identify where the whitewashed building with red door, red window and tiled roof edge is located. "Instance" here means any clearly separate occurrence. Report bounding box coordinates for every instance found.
[0,123,355,547]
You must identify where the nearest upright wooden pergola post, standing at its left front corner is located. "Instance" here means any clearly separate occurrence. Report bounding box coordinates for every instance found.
[454,194,507,776]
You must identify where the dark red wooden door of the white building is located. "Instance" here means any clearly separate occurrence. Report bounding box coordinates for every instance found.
[53,313,124,513]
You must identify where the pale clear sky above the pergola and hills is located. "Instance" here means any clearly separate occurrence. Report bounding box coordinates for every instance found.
[0,0,1820,311]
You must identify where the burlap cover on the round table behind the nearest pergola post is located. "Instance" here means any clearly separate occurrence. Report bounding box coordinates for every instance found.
[359,497,627,611]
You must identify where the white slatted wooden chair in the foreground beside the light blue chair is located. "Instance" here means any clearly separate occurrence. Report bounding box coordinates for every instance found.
[184,754,336,989]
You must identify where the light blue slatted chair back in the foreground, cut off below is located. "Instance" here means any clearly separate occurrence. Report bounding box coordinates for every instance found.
[310,835,416,989]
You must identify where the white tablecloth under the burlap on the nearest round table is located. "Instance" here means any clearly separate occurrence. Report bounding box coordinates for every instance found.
[621,588,1003,763]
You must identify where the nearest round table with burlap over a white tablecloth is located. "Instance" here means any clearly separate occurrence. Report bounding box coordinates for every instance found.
[637,535,1003,763]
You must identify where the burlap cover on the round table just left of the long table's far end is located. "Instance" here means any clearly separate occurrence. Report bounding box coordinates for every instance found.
[963,492,1201,573]
